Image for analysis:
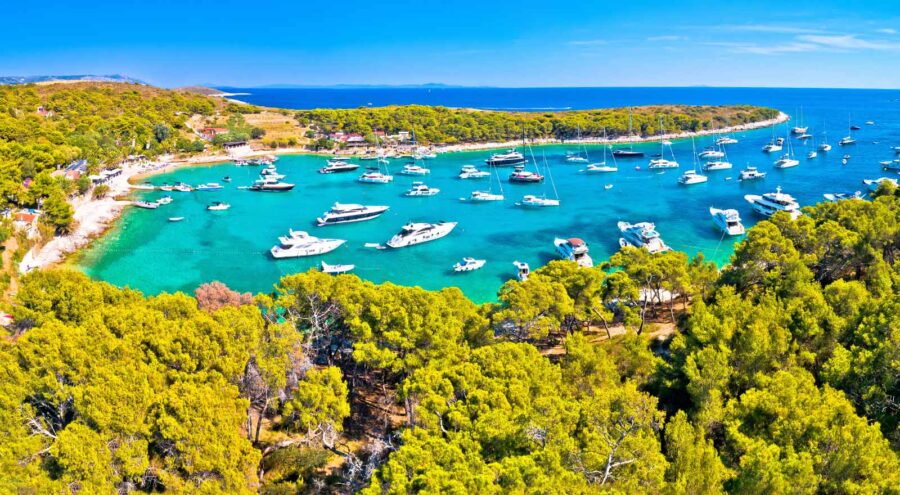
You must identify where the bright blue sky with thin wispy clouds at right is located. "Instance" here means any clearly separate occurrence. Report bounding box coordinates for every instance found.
[0,0,900,88]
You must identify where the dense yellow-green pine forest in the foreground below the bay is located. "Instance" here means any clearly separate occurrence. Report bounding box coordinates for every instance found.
[0,186,900,494]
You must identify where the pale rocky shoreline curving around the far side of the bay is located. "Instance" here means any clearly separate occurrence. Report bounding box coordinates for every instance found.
[19,111,790,274]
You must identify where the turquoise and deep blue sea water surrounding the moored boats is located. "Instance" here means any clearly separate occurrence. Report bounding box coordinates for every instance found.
[75,88,900,302]
